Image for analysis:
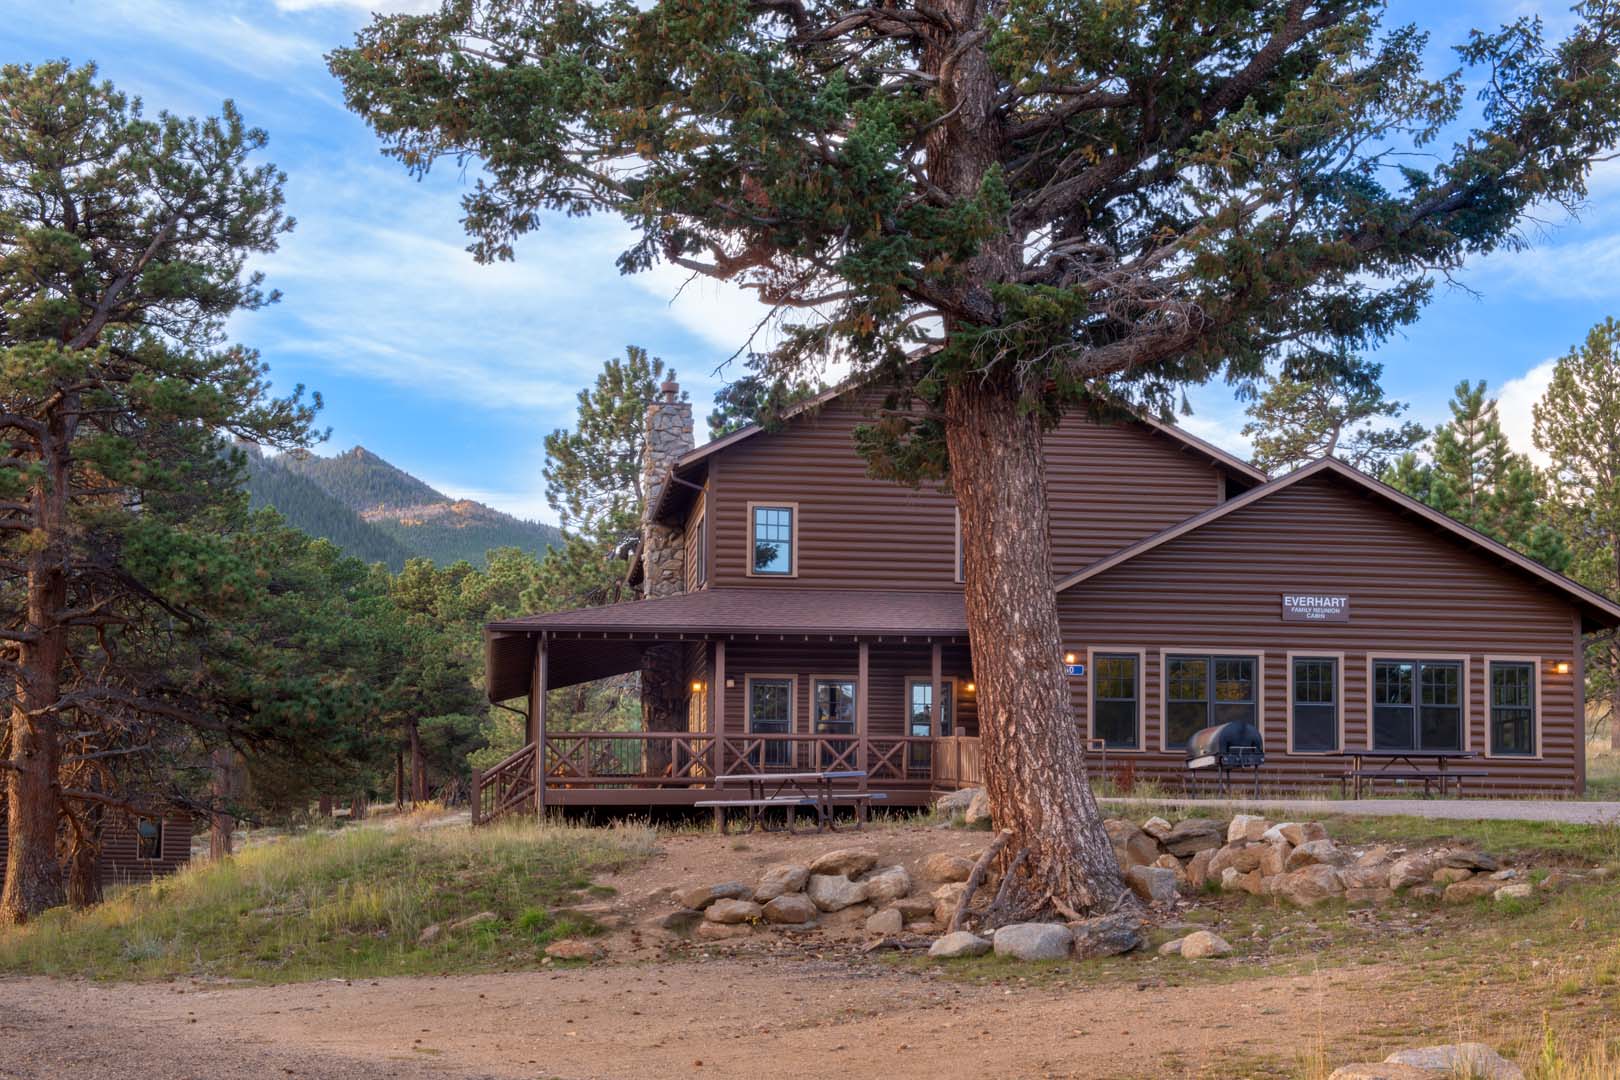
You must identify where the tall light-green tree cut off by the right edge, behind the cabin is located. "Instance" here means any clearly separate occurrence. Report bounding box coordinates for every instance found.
[1534,319,1620,748]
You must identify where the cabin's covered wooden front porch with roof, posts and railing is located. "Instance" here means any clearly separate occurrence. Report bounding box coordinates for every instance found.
[473,586,980,821]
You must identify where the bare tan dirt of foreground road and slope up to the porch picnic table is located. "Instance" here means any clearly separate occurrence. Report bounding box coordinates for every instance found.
[0,827,1587,1080]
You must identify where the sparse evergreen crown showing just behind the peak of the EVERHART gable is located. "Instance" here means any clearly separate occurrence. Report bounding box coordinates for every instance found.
[1243,358,1429,476]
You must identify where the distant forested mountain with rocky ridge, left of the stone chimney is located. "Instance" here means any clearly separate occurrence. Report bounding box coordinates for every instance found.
[248,447,562,568]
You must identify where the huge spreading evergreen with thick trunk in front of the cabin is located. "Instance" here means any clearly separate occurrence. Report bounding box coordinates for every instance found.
[330,0,1620,915]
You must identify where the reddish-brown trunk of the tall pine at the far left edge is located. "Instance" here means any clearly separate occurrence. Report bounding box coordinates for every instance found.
[0,417,78,923]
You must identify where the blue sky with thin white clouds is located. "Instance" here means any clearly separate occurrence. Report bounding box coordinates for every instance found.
[12,0,1620,521]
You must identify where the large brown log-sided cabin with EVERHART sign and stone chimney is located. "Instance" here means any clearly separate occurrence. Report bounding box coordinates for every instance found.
[475,384,1620,818]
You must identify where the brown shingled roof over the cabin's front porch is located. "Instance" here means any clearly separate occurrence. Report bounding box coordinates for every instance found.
[484,585,967,701]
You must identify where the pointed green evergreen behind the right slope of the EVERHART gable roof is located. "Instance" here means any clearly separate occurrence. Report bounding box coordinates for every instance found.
[1383,379,1570,572]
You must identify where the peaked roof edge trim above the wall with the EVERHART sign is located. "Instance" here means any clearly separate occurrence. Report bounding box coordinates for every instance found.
[1056,458,1620,627]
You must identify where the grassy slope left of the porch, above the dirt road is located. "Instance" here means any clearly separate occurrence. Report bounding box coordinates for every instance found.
[0,823,656,983]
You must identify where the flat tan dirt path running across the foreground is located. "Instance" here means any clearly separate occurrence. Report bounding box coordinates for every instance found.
[0,959,1400,1080]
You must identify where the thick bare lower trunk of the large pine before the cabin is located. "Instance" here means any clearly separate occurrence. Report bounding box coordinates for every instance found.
[944,382,1128,918]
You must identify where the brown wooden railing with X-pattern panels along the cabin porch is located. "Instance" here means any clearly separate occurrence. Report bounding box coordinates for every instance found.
[473,732,982,824]
